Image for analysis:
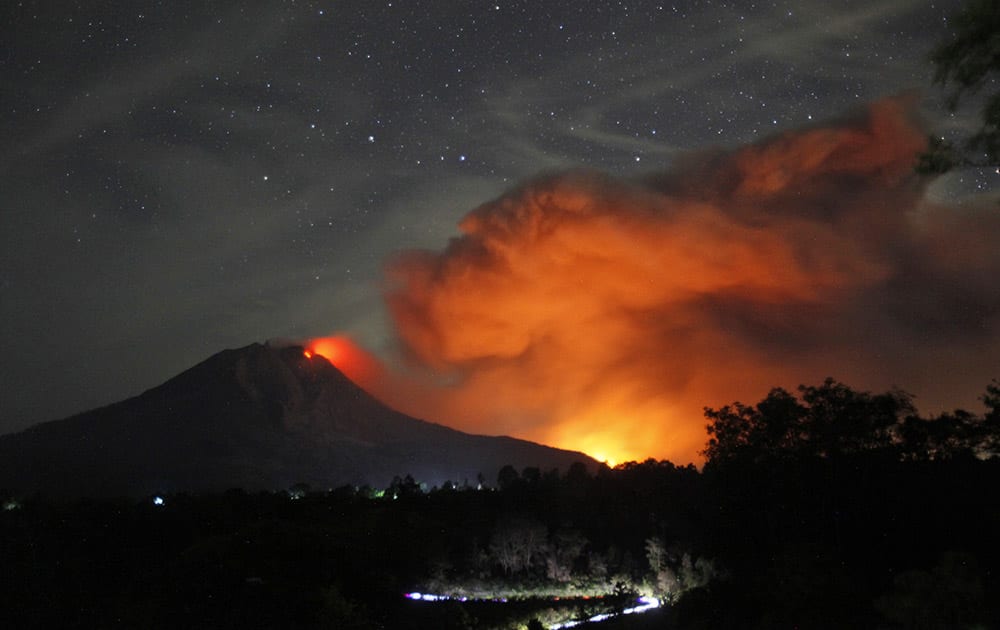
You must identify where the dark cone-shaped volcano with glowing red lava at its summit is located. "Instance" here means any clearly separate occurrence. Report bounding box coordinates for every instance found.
[0,344,597,498]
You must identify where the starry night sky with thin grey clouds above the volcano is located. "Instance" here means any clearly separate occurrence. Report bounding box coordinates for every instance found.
[0,0,997,462]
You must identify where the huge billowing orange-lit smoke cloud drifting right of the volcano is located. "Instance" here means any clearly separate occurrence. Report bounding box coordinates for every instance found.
[352,97,1000,462]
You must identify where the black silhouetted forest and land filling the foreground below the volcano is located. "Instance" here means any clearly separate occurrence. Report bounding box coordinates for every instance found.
[0,380,1000,628]
